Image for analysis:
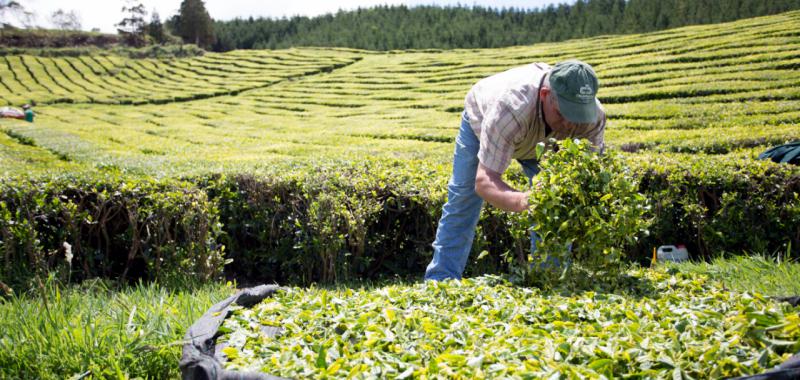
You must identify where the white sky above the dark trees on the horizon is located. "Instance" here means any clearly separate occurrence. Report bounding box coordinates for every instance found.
[9,0,574,32]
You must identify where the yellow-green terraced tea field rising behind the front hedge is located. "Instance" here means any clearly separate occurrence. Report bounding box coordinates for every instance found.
[0,12,800,175]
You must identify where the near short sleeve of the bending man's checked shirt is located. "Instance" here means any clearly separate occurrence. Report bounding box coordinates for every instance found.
[478,101,522,173]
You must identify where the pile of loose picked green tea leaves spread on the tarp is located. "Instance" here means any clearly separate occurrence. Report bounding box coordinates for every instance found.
[218,269,800,379]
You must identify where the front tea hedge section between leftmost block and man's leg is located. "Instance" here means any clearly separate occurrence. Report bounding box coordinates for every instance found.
[201,160,443,283]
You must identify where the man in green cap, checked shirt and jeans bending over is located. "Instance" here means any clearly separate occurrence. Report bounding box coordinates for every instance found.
[425,60,606,280]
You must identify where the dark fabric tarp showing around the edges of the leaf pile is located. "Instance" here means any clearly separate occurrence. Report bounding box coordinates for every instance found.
[180,285,800,380]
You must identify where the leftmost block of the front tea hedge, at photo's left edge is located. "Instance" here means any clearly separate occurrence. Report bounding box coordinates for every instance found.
[0,174,224,285]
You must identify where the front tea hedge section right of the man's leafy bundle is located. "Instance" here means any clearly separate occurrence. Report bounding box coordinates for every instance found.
[633,153,800,258]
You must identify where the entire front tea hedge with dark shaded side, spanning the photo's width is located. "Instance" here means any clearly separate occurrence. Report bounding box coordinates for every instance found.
[0,154,800,283]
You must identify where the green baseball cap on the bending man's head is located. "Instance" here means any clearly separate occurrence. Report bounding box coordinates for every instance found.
[550,59,599,124]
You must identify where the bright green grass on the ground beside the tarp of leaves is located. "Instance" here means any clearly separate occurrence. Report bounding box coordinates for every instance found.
[0,256,800,379]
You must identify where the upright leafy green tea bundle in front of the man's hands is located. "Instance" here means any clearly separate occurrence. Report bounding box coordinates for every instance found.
[520,140,649,285]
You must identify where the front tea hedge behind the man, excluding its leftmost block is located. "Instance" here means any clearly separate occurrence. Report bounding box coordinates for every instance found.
[207,154,800,283]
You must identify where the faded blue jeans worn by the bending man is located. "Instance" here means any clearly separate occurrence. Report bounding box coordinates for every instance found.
[425,115,539,281]
